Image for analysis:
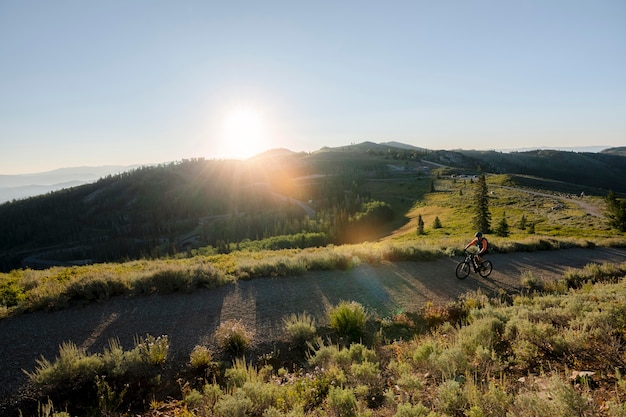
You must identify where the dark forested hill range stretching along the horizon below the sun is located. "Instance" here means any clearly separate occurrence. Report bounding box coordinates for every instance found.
[0,142,626,271]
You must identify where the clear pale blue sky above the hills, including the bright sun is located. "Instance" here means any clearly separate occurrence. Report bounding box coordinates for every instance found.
[0,0,626,174]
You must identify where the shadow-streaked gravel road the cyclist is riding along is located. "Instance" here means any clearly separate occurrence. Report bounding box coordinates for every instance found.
[0,248,626,411]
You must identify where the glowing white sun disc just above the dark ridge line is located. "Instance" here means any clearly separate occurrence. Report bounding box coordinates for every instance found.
[218,106,268,159]
